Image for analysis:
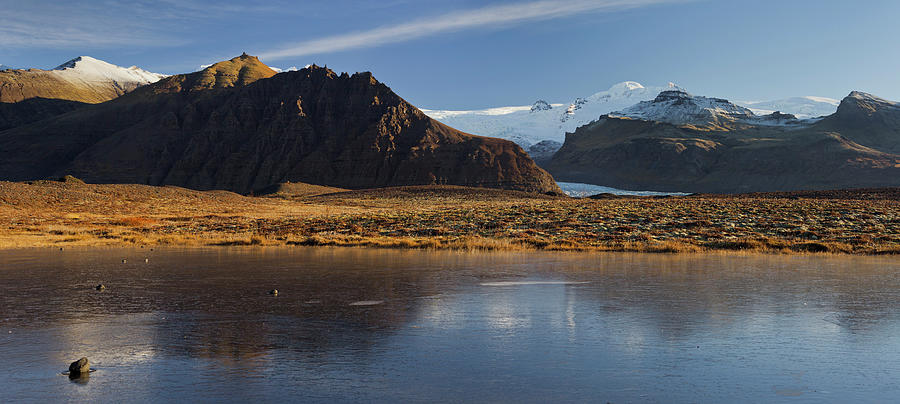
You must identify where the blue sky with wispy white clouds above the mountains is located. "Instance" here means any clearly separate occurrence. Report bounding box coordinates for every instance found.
[0,0,900,109]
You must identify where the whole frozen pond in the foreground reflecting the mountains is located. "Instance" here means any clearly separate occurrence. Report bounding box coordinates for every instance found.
[0,248,900,403]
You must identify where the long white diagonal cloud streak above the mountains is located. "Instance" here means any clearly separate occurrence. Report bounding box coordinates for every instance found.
[260,0,685,60]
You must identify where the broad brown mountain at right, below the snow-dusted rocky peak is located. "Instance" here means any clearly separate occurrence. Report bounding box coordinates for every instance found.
[545,92,900,192]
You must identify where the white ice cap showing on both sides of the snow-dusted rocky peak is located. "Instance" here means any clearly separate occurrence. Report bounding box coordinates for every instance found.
[422,81,839,149]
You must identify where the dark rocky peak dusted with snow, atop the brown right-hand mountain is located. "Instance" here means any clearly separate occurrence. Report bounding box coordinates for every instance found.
[609,89,801,127]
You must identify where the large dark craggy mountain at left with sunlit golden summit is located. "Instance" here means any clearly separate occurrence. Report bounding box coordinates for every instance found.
[0,54,559,193]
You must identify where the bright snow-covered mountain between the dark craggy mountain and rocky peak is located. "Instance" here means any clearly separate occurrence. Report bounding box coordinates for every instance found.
[422,81,678,148]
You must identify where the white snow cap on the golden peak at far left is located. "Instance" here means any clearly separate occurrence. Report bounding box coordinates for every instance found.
[50,56,167,91]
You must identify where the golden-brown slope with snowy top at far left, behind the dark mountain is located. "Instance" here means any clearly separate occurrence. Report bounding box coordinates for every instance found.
[0,56,165,130]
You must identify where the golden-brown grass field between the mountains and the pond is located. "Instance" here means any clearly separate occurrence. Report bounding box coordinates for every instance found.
[0,179,900,254]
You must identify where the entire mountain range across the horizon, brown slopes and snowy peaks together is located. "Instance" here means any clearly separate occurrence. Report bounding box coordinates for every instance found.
[0,54,900,193]
